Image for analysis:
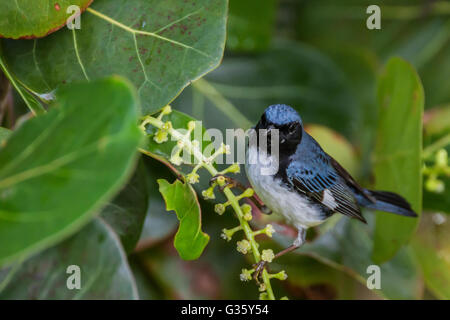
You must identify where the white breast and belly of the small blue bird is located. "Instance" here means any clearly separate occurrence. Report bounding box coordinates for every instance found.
[245,147,325,228]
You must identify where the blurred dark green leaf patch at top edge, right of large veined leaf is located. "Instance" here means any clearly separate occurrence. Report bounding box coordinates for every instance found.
[227,0,278,51]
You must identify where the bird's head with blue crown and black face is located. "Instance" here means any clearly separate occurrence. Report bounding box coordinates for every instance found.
[255,104,303,153]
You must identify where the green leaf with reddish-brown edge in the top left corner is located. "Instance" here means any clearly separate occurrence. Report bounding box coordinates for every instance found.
[0,0,92,39]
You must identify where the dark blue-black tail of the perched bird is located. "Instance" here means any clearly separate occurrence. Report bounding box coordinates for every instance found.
[363,190,417,217]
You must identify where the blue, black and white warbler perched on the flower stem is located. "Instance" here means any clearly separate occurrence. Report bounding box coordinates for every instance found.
[245,104,417,270]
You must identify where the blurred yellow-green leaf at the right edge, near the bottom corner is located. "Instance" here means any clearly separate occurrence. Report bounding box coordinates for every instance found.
[412,214,450,300]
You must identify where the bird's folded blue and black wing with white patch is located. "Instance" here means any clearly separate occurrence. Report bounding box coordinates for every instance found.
[287,161,366,222]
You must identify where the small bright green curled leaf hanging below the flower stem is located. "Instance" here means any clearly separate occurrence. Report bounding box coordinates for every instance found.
[158,179,209,260]
